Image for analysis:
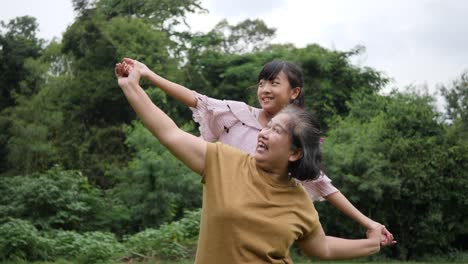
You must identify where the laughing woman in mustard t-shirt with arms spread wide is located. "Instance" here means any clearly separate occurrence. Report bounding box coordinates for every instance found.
[115,60,383,264]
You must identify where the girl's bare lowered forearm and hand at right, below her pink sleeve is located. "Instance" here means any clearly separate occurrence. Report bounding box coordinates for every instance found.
[324,191,396,246]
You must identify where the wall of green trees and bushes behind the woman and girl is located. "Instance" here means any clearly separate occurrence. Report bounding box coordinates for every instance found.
[0,0,468,263]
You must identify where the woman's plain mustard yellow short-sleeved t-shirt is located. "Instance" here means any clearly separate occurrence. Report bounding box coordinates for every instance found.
[195,143,320,264]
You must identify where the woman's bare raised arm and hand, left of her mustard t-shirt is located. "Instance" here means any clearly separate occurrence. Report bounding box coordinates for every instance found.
[115,63,207,174]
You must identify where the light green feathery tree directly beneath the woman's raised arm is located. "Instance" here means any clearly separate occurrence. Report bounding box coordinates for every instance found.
[112,119,201,232]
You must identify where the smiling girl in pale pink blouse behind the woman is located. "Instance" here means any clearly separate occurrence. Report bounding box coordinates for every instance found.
[121,58,396,245]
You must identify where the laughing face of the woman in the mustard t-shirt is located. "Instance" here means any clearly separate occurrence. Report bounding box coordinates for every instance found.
[254,114,293,170]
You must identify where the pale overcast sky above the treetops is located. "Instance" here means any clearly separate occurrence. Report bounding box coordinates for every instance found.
[0,0,468,102]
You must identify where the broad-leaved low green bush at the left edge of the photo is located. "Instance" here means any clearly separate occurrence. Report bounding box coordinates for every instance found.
[0,167,125,231]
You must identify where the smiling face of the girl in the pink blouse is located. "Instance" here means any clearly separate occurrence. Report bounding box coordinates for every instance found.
[257,71,300,115]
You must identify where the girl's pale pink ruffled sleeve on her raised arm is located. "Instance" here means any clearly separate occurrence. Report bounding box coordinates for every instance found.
[190,92,241,142]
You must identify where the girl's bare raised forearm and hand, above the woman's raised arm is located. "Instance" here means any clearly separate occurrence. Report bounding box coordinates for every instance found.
[123,58,197,108]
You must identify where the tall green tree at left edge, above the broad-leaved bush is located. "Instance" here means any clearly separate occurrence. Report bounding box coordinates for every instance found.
[0,42,77,175]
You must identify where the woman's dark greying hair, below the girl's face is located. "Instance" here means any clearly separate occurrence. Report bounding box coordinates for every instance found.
[280,105,322,181]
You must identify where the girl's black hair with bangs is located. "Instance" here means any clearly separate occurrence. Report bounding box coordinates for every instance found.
[257,60,304,108]
